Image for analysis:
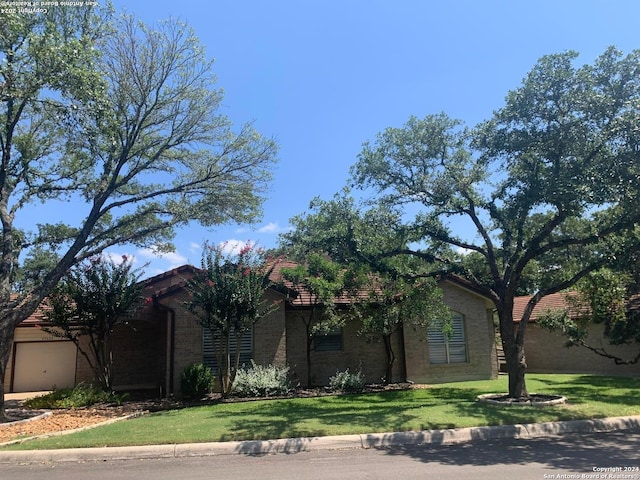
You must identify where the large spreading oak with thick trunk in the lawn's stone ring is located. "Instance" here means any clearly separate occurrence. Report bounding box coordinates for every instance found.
[284,48,640,398]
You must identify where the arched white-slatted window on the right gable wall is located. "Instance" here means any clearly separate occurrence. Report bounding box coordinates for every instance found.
[427,312,467,364]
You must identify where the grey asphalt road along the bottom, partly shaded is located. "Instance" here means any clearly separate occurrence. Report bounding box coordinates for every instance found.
[5,431,640,480]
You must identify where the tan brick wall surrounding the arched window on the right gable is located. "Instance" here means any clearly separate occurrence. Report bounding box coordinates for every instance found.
[404,282,498,383]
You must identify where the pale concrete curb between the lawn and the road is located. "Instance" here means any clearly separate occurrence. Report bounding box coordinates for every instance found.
[0,415,640,464]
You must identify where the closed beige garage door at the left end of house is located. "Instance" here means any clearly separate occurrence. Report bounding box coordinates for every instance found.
[13,342,77,392]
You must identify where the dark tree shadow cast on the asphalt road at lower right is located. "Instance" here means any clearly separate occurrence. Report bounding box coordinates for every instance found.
[380,431,638,468]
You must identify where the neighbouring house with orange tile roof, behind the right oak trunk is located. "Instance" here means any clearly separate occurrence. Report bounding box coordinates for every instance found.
[513,292,640,375]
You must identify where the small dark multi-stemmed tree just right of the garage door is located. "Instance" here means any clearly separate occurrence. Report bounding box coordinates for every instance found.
[43,256,143,392]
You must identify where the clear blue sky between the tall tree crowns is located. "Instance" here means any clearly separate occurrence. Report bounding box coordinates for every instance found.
[33,0,640,275]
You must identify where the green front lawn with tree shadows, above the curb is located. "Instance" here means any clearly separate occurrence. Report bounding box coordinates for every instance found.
[5,374,640,449]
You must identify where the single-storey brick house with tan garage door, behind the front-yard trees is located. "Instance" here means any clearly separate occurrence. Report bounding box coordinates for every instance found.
[4,262,497,395]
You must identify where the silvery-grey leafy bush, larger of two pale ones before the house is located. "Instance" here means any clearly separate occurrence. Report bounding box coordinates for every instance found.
[231,360,293,397]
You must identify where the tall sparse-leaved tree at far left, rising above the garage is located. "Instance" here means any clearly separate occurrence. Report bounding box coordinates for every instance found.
[0,8,277,420]
